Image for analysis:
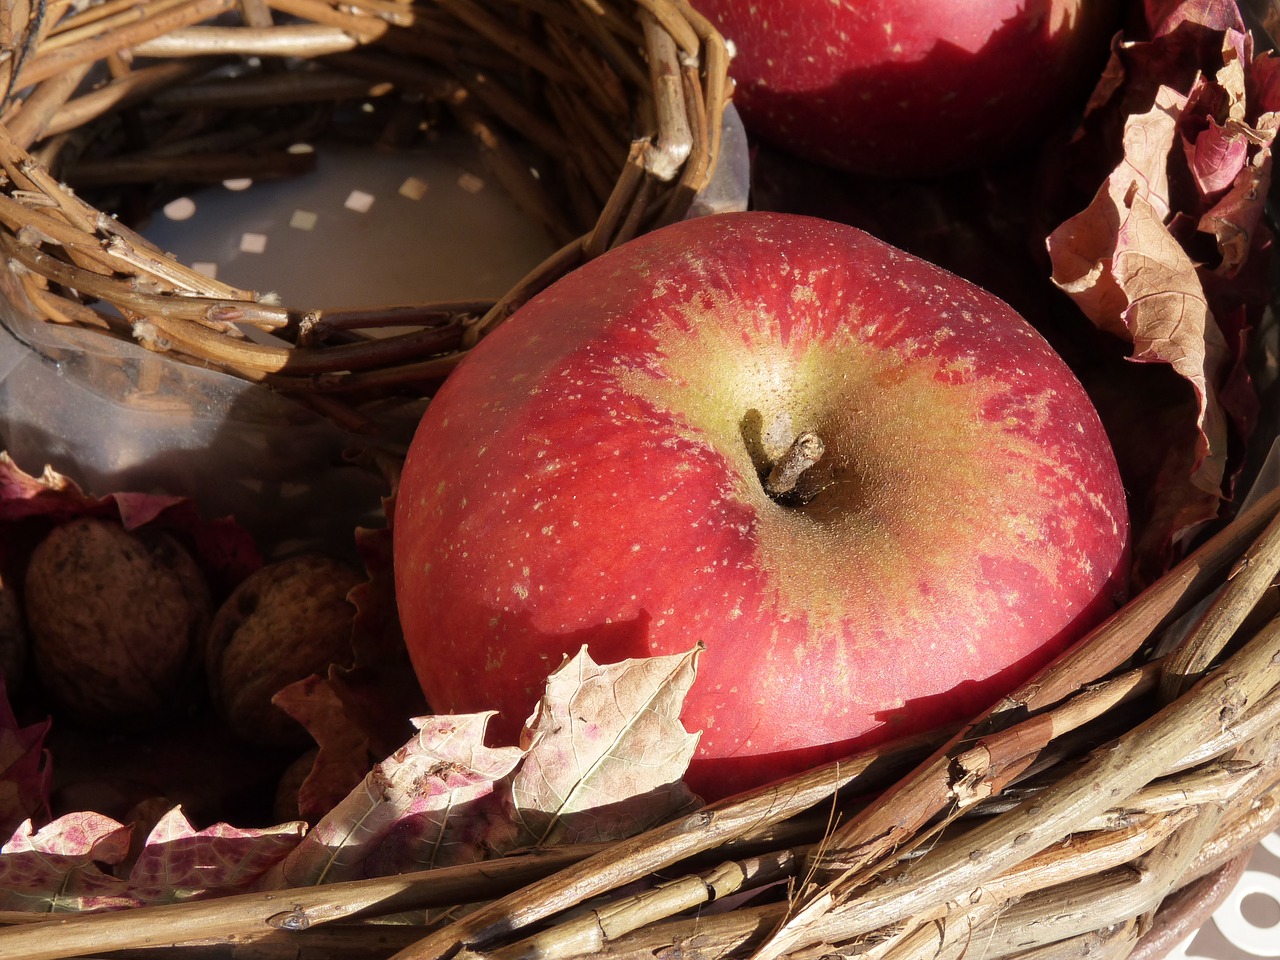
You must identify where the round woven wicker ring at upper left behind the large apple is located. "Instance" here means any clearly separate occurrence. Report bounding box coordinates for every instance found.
[0,0,728,430]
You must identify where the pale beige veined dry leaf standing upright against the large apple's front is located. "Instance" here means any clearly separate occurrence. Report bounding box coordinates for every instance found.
[512,645,701,844]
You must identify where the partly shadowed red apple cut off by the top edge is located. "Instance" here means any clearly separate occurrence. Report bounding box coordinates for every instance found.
[698,0,1123,177]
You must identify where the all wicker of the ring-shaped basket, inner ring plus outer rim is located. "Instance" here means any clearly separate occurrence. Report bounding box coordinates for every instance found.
[0,0,1280,960]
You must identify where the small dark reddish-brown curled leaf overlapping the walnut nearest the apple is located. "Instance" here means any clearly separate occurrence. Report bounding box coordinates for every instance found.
[271,676,371,823]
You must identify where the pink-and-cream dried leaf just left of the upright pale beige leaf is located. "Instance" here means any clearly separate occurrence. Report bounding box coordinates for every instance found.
[283,713,525,886]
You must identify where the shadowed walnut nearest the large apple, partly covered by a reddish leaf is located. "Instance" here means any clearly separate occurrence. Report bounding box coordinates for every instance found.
[206,553,364,746]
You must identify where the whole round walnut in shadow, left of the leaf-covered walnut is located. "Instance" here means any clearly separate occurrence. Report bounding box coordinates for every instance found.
[23,517,212,721]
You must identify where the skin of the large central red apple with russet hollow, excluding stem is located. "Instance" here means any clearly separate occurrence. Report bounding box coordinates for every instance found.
[394,212,1128,797]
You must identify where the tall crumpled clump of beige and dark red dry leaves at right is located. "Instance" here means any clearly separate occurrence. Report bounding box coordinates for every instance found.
[1048,0,1280,570]
